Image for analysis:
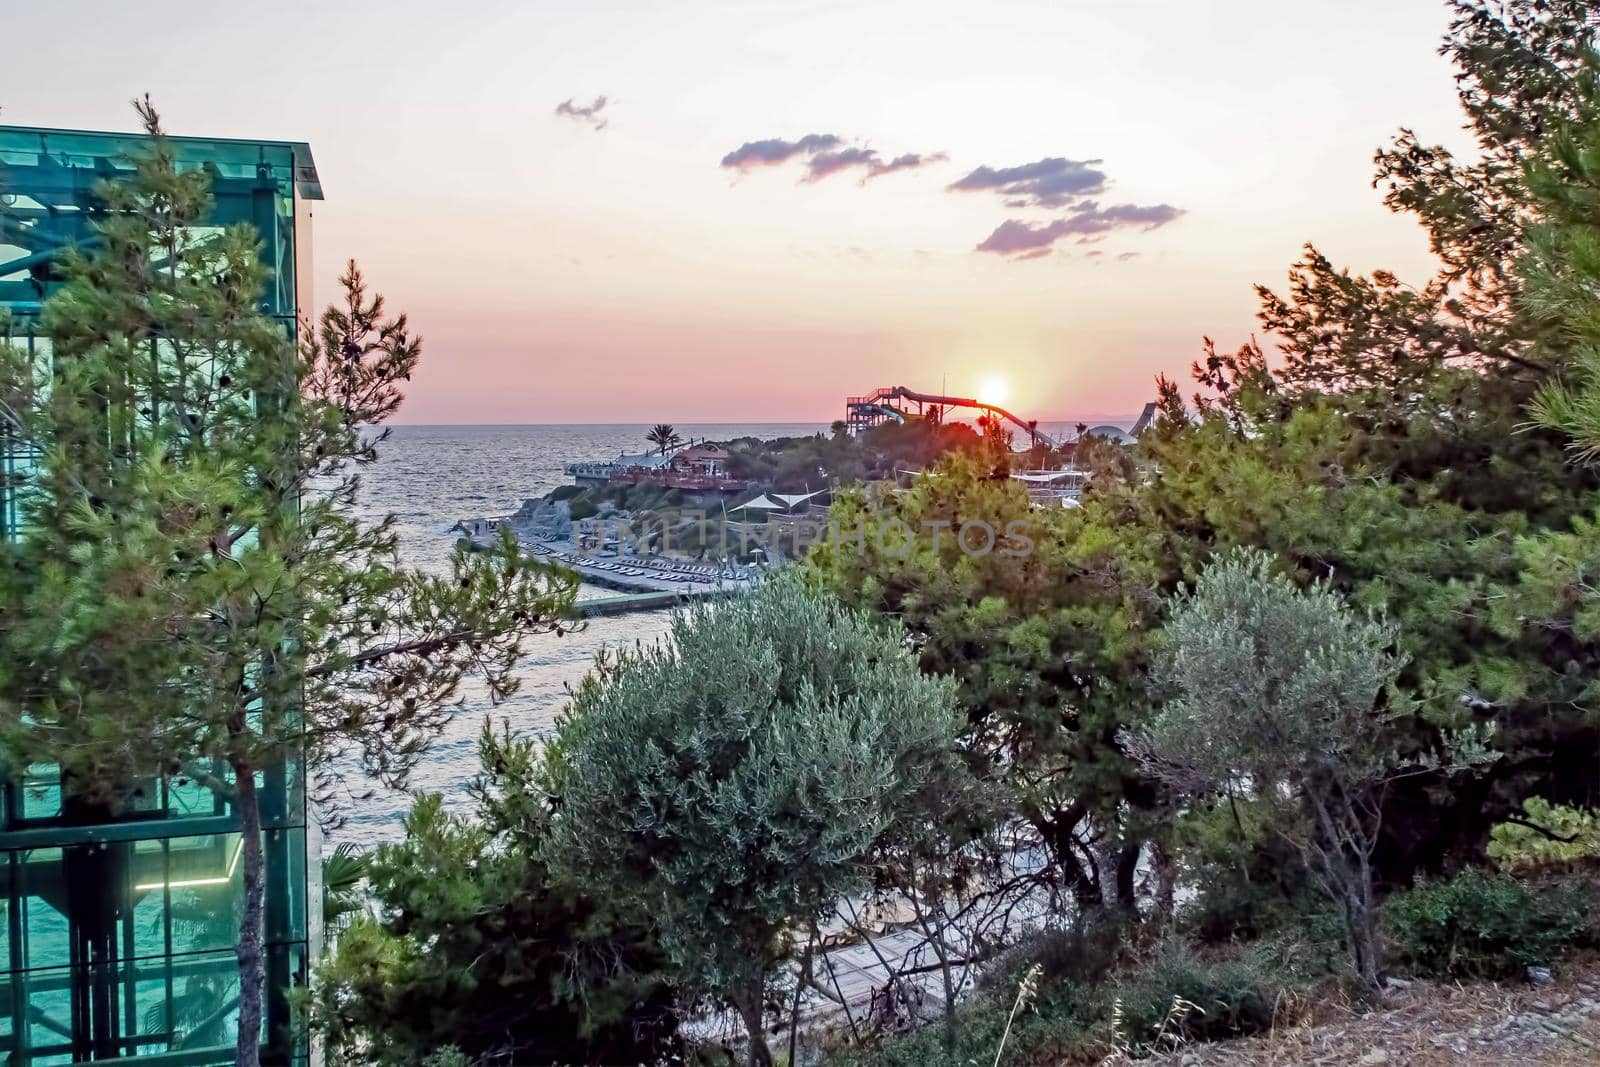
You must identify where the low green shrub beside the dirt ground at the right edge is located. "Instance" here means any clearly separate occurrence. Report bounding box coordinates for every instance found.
[1384,870,1592,977]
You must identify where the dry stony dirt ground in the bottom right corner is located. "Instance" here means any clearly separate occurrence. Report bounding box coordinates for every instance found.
[1141,960,1600,1067]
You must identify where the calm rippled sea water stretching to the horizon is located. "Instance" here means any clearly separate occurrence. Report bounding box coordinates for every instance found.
[344,422,827,845]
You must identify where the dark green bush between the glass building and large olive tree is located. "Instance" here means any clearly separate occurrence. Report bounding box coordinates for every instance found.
[309,725,678,1067]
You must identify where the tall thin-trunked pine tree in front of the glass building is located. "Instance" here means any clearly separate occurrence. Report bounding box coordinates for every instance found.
[0,101,574,1067]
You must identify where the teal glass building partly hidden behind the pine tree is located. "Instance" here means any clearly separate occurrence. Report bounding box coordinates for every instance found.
[0,126,322,1067]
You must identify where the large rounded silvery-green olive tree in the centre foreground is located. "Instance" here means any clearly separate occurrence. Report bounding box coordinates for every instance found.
[547,573,955,1064]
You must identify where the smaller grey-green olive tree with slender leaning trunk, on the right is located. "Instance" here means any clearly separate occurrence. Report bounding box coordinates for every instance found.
[1131,549,1491,992]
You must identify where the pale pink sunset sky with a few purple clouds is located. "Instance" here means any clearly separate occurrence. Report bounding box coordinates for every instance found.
[0,0,1467,424]
